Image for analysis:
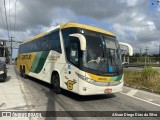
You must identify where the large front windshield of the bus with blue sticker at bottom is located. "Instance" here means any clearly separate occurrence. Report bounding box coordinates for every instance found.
[83,35,122,73]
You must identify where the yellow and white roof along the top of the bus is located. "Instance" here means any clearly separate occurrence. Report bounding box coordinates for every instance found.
[22,22,115,44]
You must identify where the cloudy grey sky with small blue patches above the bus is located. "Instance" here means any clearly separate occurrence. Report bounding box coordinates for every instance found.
[0,0,160,57]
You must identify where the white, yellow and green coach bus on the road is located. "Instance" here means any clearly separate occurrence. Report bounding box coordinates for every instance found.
[17,22,133,95]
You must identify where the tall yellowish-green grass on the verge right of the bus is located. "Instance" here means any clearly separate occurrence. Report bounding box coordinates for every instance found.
[124,67,160,93]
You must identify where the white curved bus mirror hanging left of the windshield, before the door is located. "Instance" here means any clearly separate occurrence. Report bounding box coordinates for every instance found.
[69,33,86,51]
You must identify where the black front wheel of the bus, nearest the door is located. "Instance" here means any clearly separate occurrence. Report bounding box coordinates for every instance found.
[52,74,61,94]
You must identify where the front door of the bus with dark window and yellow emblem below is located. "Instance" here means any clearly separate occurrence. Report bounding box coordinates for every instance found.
[64,37,80,93]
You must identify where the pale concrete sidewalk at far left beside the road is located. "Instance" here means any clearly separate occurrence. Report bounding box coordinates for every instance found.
[0,65,26,110]
